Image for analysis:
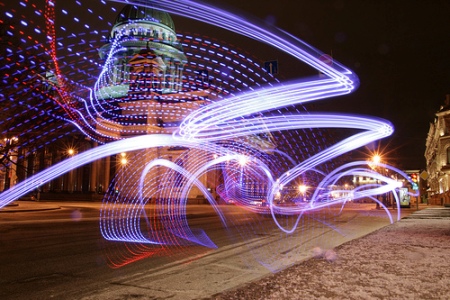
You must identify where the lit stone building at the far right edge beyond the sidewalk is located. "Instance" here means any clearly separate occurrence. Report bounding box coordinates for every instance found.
[425,95,450,205]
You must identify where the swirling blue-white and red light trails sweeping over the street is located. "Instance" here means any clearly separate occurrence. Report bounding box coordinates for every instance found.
[0,0,418,266]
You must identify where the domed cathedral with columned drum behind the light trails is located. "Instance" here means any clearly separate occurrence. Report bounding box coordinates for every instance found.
[89,5,215,202]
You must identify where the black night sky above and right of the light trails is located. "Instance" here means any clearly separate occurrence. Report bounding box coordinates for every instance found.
[174,0,450,169]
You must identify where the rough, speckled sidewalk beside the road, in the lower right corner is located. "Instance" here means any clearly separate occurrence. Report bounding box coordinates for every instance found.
[211,207,450,300]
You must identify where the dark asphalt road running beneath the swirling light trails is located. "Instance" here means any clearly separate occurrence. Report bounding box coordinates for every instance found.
[0,203,400,299]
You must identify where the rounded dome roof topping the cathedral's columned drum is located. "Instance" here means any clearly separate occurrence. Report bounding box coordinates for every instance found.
[114,4,175,31]
